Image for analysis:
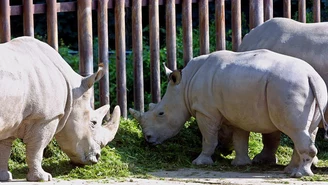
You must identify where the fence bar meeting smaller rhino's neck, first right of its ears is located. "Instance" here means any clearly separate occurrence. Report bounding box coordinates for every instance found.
[182,0,193,66]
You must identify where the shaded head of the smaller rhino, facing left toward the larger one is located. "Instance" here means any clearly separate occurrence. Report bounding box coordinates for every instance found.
[129,66,190,145]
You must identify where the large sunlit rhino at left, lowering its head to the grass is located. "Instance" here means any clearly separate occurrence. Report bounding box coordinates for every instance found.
[0,37,121,181]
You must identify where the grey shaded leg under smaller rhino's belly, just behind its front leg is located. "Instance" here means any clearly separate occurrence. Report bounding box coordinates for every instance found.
[231,128,252,166]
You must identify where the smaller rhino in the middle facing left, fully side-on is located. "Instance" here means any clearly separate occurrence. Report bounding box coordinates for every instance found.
[129,50,327,177]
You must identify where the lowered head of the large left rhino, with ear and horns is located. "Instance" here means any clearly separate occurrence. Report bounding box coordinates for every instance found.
[56,67,121,164]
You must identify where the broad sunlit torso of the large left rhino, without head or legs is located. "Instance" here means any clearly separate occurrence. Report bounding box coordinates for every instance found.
[0,37,68,139]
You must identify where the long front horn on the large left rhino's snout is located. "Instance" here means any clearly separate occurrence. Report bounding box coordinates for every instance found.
[100,105,121,147]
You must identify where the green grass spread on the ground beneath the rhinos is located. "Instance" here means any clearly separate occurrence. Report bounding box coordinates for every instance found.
[9,119,328,181]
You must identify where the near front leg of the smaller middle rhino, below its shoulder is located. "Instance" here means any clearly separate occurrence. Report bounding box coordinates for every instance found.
[192,113,220,165]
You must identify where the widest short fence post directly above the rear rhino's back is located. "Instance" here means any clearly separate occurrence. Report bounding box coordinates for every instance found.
[249,0,264,29]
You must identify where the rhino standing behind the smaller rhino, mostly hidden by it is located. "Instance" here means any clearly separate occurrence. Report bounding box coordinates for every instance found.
[215,18,328,169]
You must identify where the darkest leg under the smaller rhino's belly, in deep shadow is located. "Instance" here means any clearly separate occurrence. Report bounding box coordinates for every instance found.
[253,131,281,165]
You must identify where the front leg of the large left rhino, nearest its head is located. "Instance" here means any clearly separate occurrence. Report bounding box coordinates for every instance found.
[23,119,58,181]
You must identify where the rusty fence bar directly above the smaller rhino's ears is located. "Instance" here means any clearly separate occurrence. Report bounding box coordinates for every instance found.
[166,0,177,70]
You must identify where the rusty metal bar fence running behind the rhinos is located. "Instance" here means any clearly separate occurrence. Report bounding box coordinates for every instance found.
[0,0,320,117]
